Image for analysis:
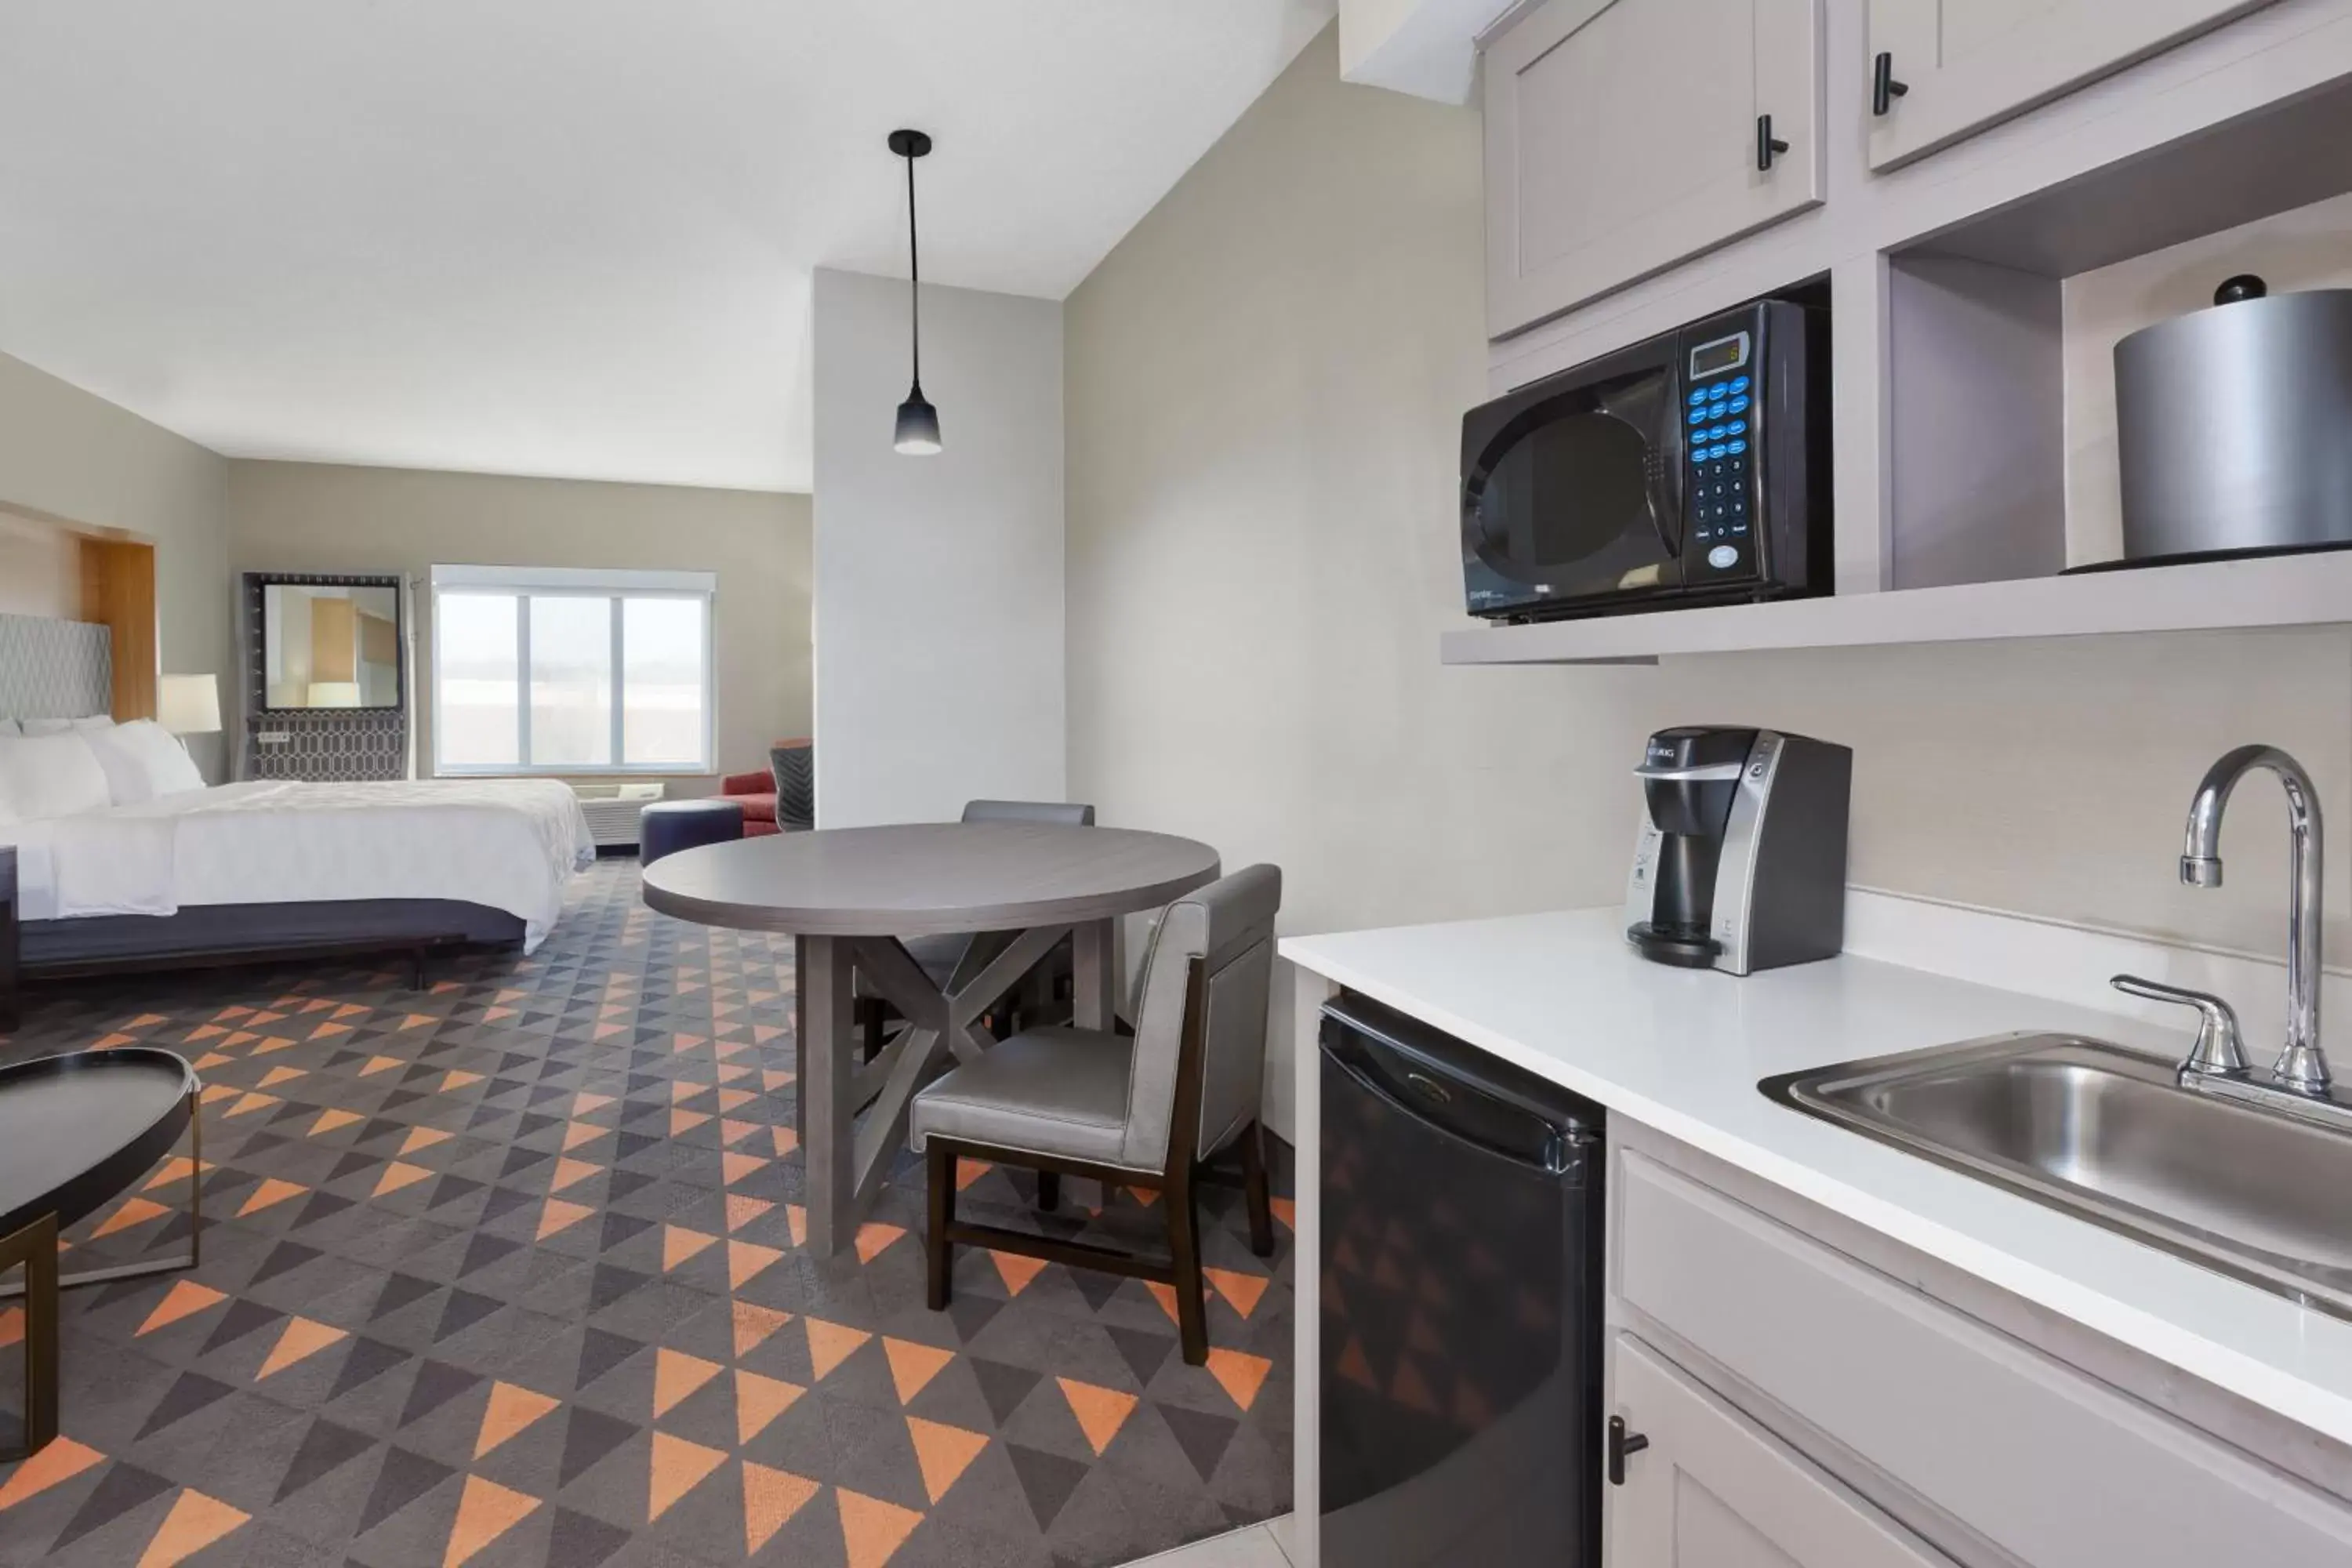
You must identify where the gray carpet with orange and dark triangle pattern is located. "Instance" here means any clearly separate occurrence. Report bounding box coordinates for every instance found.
[0,860,1291,1568]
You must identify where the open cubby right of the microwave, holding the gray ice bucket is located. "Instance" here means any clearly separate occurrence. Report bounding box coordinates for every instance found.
[1879,64,2352,590]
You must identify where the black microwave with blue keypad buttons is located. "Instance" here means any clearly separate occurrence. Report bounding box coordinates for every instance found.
[1461,299,1830,621]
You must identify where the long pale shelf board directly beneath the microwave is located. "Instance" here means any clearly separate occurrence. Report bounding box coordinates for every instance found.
[1439,550,2352,666]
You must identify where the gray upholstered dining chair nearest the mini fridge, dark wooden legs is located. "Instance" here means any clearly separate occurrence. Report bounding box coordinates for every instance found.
[908,865,1282,1366]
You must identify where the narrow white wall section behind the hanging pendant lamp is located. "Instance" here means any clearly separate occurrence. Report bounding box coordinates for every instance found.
[811,270,1065,827]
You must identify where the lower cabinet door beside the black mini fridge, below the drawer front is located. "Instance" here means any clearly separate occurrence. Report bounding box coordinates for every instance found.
[1604,1333,1952,1568]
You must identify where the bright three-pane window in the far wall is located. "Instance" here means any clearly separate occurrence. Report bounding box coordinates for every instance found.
[433,567,715,774]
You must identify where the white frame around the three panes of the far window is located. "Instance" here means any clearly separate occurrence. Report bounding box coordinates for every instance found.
[428,567,720,779]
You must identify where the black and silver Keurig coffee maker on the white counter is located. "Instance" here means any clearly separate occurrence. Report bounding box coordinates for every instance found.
[1625,727,1853,975]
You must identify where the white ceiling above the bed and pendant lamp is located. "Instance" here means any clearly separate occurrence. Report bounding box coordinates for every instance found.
[0,0,1331,489]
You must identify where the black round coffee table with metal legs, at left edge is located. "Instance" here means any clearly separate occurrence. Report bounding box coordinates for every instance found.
[0,1046,205,1462]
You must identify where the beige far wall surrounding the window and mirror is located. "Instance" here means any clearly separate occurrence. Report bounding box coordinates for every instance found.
[228,461,809,792]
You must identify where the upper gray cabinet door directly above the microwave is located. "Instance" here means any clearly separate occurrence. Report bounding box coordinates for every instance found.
[1486,0,1823,336]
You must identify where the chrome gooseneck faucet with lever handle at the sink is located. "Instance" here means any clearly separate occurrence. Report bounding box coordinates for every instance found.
[2112,746,2352,1123]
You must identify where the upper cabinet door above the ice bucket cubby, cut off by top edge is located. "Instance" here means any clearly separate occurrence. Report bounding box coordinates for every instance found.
[1865,0,2270,169]
